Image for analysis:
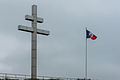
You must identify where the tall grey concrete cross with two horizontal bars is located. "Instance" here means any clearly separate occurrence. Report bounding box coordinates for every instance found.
[18,5,49,79]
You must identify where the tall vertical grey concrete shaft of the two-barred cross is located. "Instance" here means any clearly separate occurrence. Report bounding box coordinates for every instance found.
[31,5,37,78]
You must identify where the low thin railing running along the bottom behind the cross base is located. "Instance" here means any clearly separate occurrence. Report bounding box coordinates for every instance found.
[0,73,84,80]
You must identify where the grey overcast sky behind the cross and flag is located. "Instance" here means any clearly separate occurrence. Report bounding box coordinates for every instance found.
[0,0,120,80]
